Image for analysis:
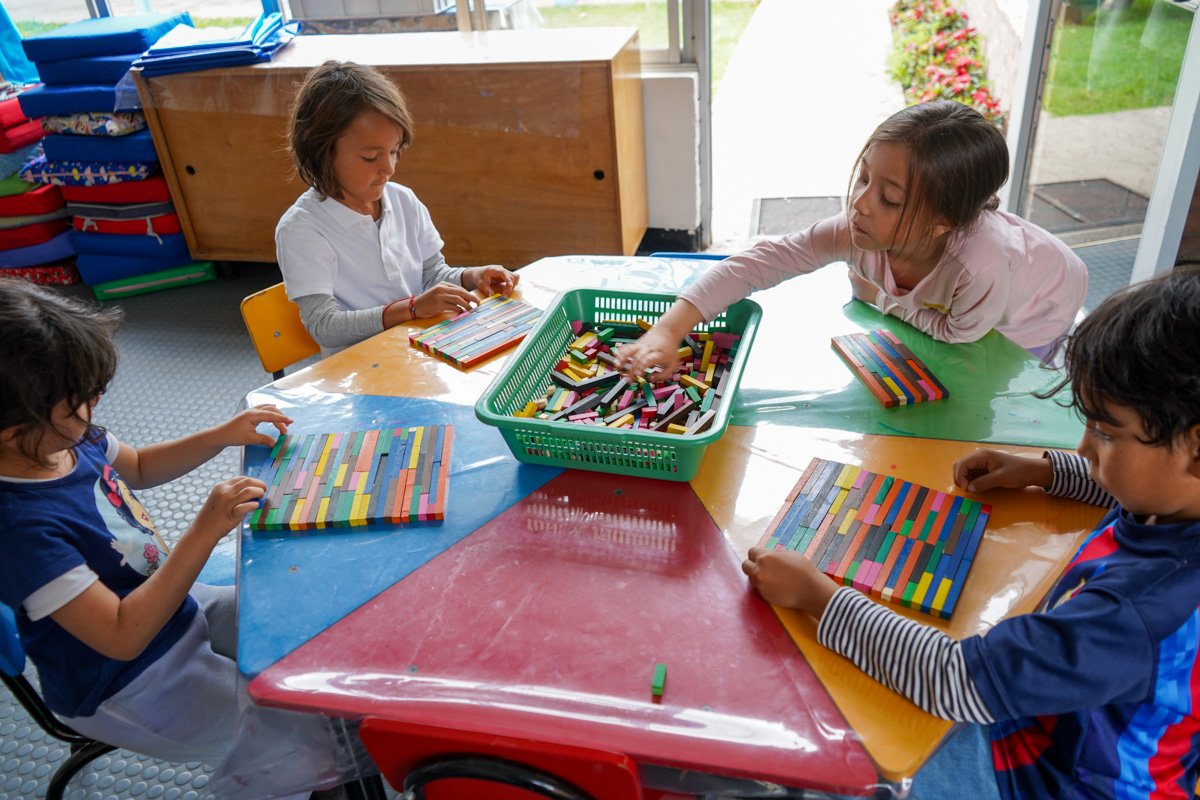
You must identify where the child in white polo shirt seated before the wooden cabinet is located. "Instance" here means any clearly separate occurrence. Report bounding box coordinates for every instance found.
[275,61,518,354]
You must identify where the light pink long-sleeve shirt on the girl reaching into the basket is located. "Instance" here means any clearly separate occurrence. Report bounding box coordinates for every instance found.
[679,211,1087,348]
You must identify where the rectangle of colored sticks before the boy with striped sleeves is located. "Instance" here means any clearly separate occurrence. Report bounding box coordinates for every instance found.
[758,458,991,619]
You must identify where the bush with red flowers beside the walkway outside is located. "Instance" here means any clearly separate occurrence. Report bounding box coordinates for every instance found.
[890,0,1003,125]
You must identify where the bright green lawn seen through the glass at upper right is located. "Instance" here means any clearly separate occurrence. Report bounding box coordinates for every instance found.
[1043,0,1192,116]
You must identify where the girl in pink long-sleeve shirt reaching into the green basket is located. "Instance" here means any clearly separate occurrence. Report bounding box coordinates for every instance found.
[620,101,1087,374]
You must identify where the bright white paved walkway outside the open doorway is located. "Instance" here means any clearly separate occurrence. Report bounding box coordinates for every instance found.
[712,0,904,252]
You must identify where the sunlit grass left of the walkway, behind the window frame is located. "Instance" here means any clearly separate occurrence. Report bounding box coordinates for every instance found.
[539,0,758,94]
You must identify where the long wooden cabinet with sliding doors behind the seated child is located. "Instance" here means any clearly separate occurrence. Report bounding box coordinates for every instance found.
[136,28,647,267]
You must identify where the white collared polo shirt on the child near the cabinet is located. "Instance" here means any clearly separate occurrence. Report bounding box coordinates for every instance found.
[275,182,443,308]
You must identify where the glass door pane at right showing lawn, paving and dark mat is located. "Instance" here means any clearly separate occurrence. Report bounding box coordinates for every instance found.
[1010,0,1194,311]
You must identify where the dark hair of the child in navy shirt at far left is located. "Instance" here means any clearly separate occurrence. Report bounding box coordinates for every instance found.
[0,278,122,467]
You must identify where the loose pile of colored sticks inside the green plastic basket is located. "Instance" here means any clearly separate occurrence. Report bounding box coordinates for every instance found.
[515,319,742,435]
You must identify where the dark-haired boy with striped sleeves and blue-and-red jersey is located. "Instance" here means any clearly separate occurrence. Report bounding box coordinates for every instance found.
[743,270,1200,799]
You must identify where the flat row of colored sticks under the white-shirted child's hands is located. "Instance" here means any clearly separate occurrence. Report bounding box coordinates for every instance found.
[408,295,541,367]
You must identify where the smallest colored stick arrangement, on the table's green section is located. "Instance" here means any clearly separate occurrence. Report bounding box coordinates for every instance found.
[833,329,950,408]
